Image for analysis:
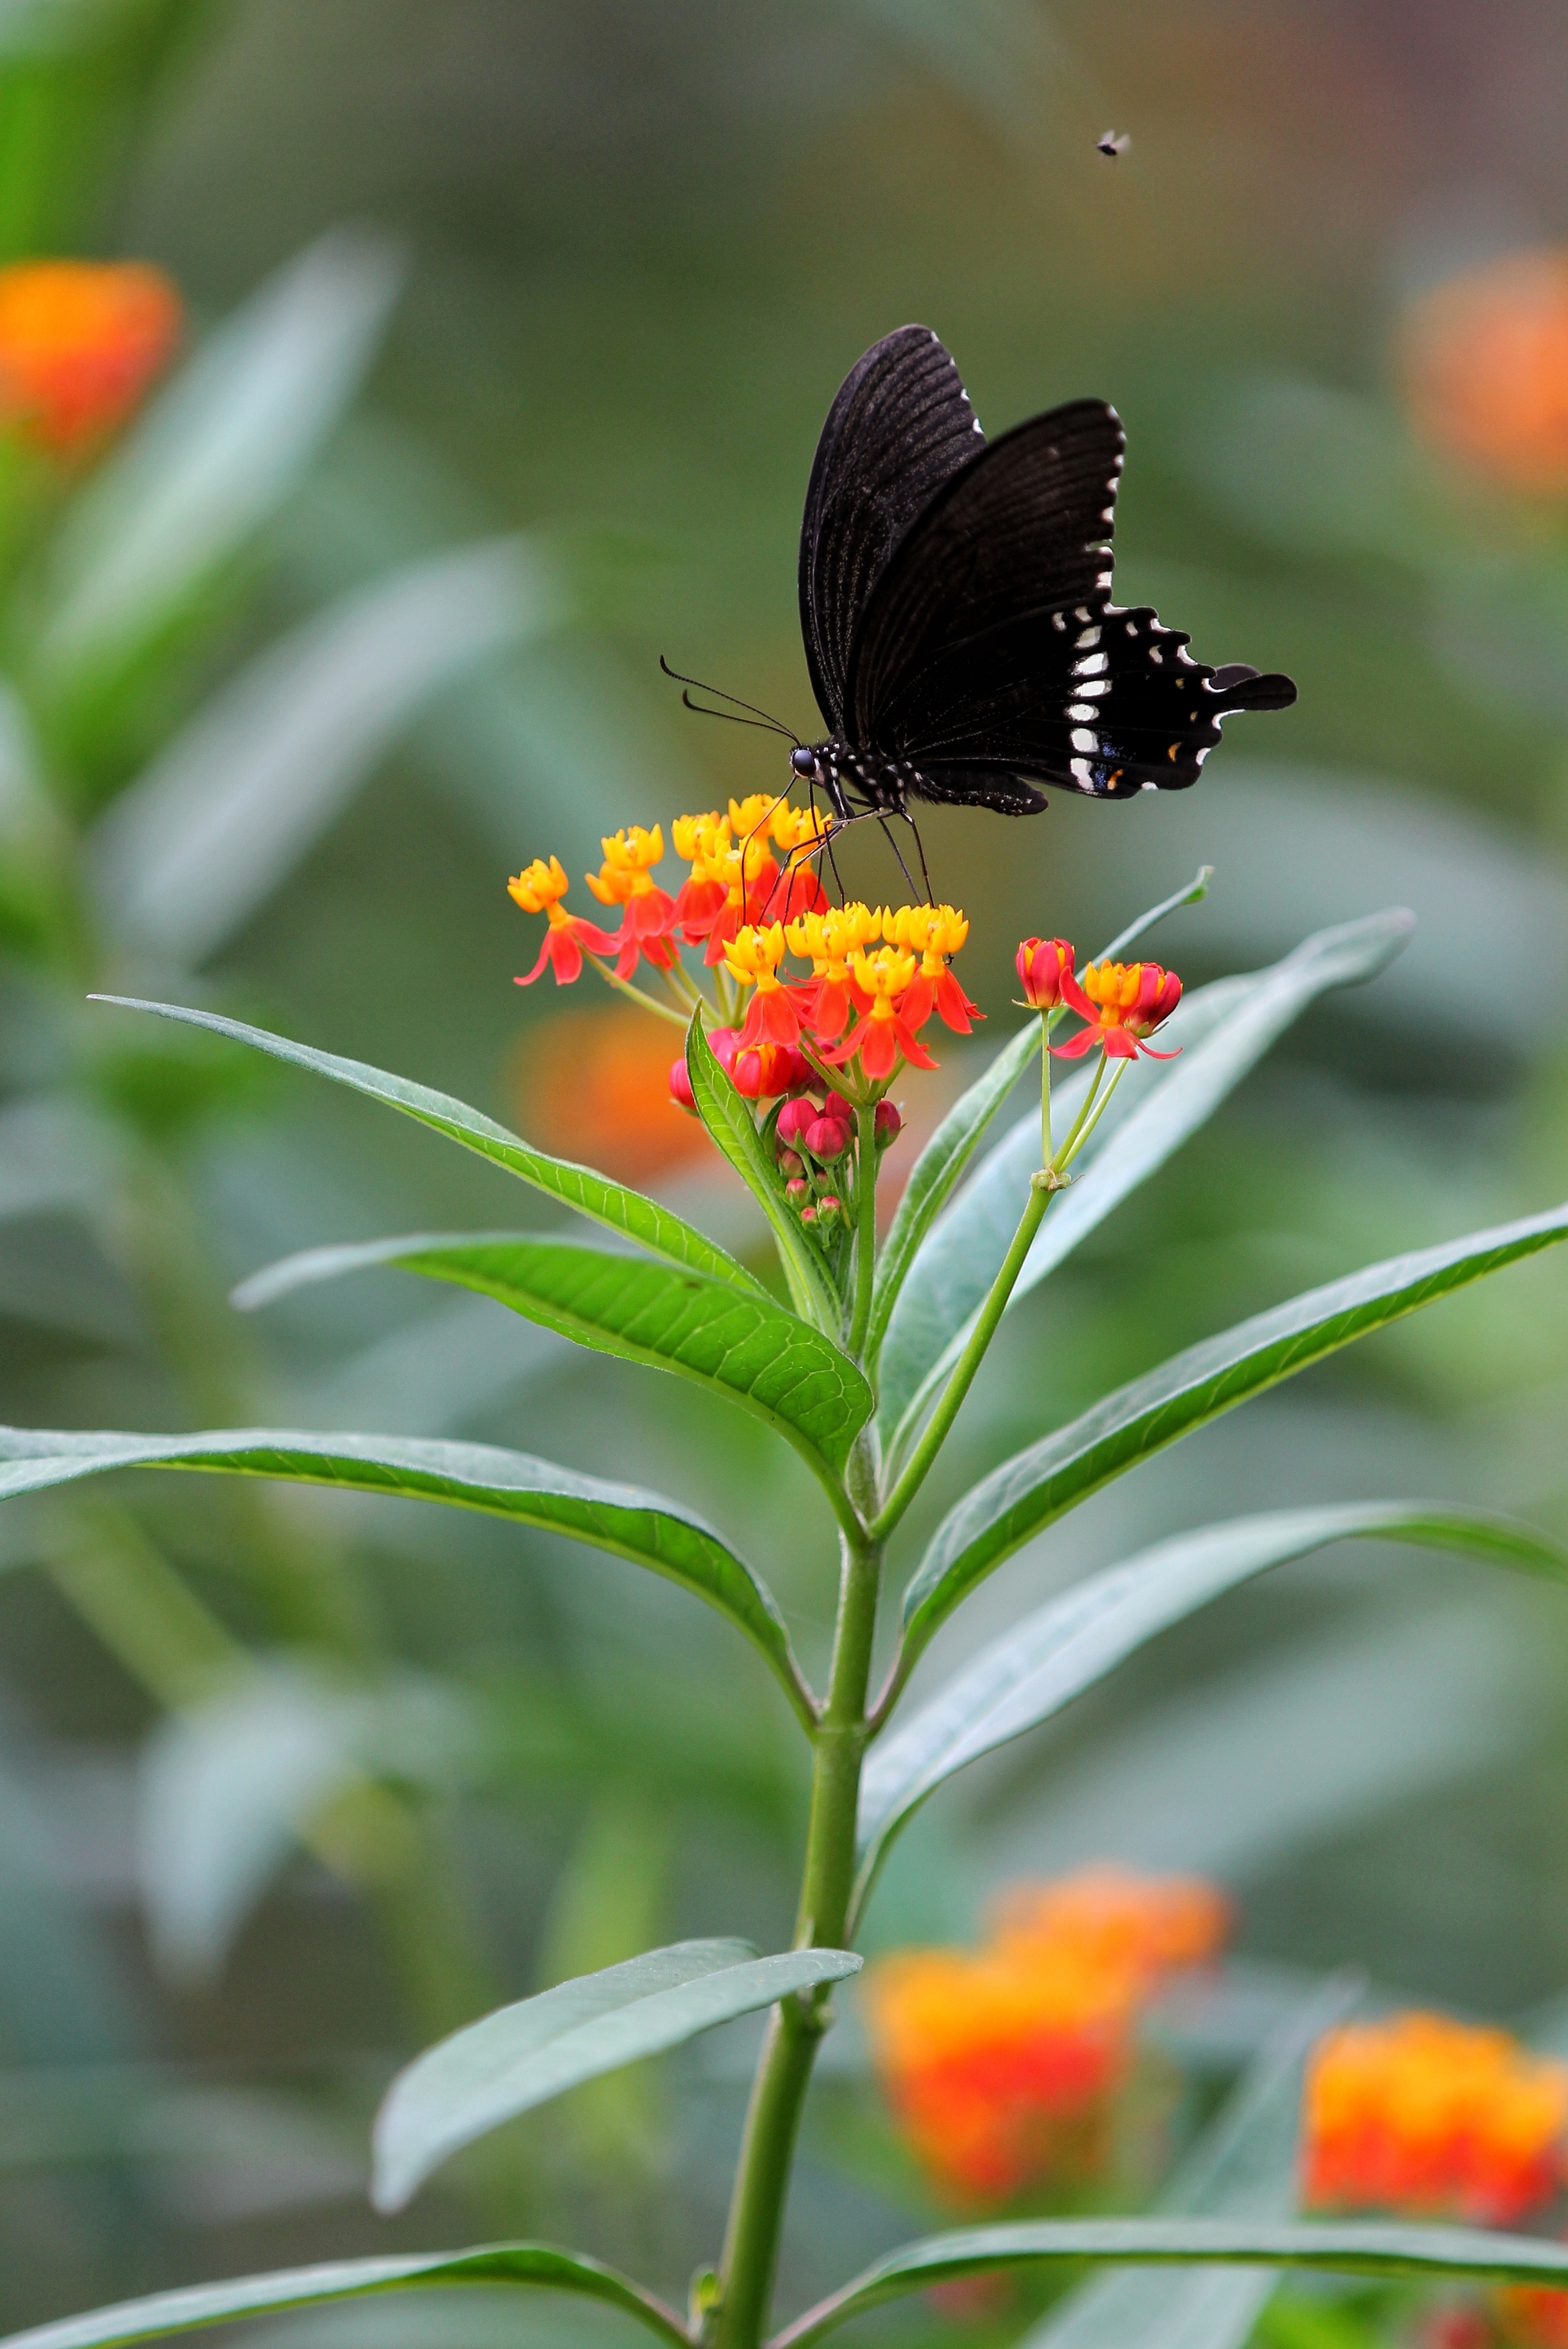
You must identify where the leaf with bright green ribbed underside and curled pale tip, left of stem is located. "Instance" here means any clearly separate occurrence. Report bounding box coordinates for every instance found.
[234,1231,871,1470]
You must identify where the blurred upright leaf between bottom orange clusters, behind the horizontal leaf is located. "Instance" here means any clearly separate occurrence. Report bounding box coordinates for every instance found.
[1024,1976,1361,2349]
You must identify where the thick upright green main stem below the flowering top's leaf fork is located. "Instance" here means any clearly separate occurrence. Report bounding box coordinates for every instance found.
[704,1536,883,2349]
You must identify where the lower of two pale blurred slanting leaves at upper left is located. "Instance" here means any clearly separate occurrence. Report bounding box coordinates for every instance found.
[89,538,554,963]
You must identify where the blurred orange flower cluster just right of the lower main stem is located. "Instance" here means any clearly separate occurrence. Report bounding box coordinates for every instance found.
[866,1868,1230,2203]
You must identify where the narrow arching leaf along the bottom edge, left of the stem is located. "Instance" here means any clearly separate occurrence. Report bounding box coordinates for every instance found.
[0,2243,690,2349]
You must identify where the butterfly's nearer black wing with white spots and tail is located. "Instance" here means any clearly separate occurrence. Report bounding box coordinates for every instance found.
[847,399,1296,810]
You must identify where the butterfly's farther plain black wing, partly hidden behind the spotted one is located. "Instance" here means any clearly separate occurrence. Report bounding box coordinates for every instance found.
[801,327,986,733]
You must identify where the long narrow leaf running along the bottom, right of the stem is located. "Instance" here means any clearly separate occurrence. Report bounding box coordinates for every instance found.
[775,2218,1568,2349]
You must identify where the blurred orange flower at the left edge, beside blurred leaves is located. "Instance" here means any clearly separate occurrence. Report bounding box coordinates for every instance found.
[0,261,181,456]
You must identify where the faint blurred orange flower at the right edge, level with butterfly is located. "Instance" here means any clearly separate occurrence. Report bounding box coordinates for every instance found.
[1399,247,1568,496]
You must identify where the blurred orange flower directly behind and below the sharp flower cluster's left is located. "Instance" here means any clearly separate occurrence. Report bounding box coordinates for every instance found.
[512,1003,711,1181]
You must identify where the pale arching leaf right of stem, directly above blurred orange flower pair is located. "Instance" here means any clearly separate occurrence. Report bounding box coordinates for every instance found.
[859,1501,1568,1865]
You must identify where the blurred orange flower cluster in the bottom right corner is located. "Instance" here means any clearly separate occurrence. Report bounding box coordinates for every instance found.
[1303,2013,1568,2227]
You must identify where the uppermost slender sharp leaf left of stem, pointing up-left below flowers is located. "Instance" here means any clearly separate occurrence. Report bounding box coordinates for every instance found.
[91,996,767,1297]
